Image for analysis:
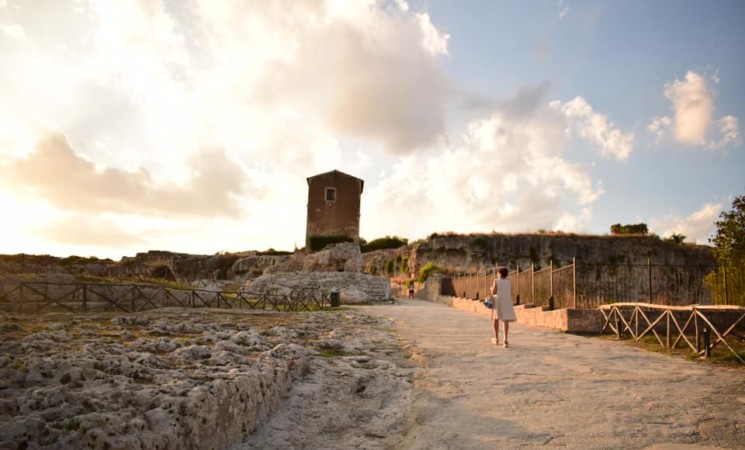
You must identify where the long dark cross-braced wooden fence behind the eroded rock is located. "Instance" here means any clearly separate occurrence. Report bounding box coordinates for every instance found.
[0,276,331,313]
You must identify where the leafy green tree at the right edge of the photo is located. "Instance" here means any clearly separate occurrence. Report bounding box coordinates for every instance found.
[709,195,745,266]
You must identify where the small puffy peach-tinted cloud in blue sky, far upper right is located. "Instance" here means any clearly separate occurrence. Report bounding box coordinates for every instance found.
[647,71,740,150]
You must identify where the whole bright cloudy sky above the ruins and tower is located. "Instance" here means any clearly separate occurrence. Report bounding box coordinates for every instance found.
[0,0,745,259]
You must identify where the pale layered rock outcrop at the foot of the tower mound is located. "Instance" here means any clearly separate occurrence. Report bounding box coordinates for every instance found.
[245,272,391,304]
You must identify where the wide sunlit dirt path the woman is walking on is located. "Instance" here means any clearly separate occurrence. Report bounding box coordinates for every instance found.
[359,300,745,450]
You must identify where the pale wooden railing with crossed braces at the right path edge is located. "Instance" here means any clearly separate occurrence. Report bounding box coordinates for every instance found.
[598,303,745,364]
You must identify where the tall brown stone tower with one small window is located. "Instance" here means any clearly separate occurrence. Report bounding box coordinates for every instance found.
[305,170,365,250]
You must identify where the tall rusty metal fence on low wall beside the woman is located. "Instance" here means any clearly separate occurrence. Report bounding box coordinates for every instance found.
[443,260,745,308]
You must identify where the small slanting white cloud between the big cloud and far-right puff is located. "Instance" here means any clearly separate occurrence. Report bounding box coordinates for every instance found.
[551,97,634,161]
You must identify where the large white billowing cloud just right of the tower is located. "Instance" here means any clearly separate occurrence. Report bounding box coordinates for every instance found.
[362,98,603,238]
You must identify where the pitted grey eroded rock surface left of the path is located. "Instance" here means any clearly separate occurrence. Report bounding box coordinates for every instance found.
[0,309,414,450]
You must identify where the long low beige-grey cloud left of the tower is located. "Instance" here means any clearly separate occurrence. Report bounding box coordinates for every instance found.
[0,134,244,217]
